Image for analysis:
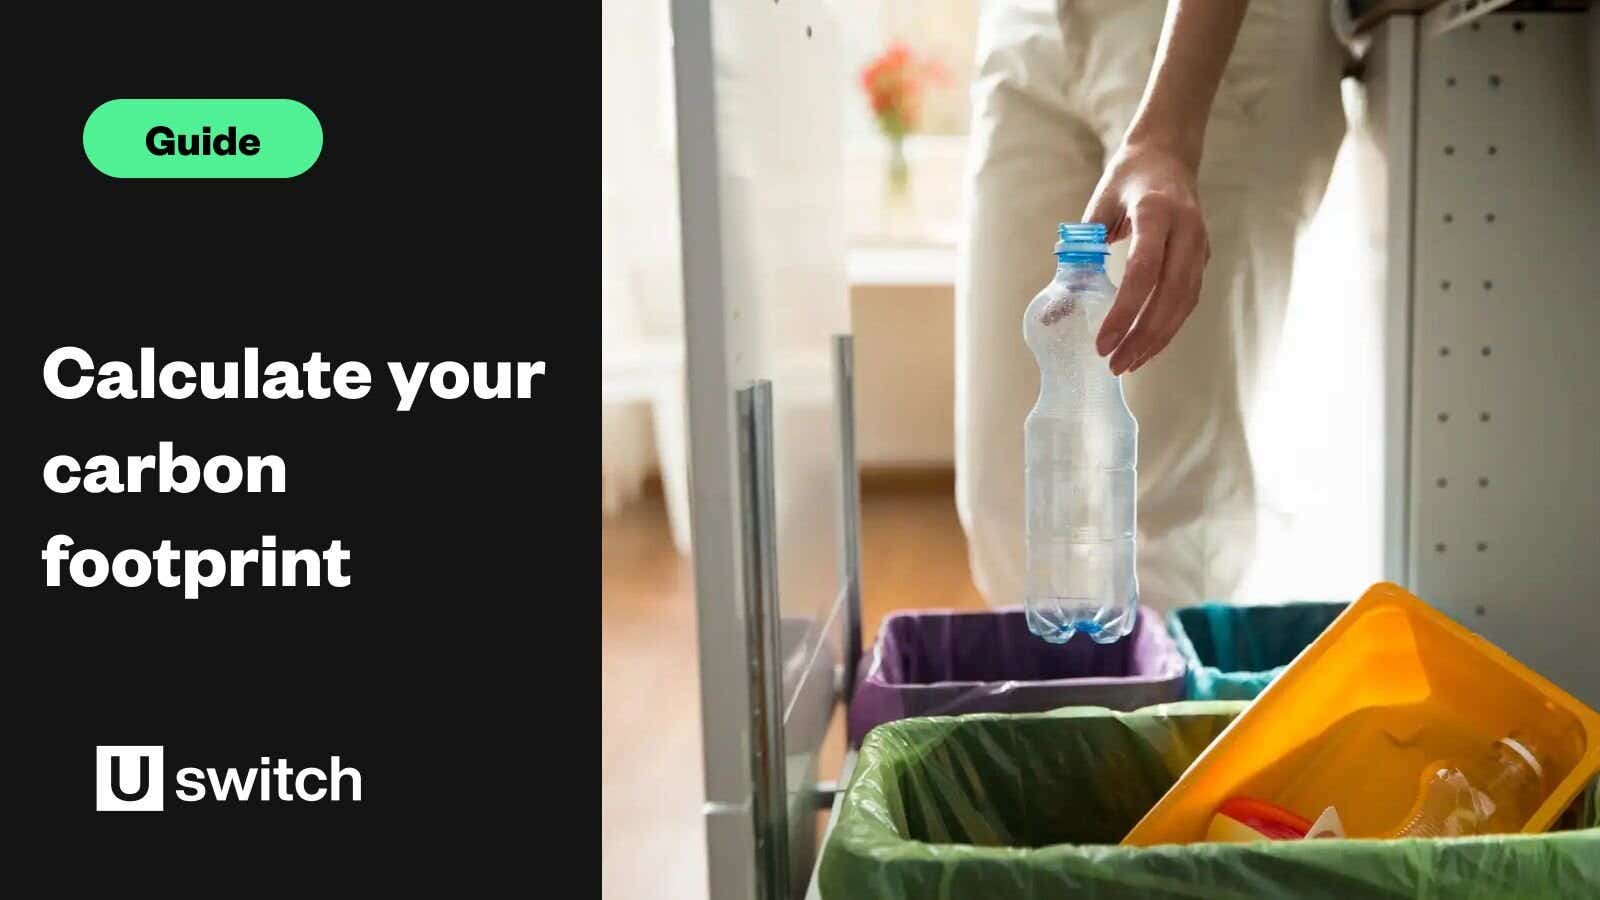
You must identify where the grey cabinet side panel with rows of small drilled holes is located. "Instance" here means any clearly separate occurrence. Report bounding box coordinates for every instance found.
[1410,13,1600,705]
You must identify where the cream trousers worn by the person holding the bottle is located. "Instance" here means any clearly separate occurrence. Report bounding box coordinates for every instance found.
[955,0,1344,610]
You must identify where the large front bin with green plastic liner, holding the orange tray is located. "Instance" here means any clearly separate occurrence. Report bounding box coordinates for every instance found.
[818,701,1600,900]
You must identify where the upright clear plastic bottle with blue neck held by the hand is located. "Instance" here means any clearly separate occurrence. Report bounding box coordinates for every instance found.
[1022,224,1139,644]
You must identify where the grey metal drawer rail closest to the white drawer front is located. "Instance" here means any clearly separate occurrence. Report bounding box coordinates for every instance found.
[738,381,789,900]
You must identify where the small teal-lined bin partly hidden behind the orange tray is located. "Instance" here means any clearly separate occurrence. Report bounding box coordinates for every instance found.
[1166,602,1350,700]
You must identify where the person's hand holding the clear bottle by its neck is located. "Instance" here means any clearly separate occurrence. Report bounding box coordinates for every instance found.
[1083,144,1211,375]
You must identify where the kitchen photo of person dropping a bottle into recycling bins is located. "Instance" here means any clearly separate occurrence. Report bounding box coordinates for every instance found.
[600,0,1600,900]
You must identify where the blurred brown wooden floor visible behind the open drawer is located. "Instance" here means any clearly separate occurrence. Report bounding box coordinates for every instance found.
[600,477,982,900]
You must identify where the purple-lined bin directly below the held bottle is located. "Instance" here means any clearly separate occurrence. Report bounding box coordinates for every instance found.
[850,607,1184,746]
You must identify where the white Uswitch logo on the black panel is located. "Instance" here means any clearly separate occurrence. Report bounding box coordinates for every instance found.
[94,746,362,812]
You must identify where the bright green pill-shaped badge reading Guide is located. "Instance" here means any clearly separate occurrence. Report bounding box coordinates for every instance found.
[83,99,322,178]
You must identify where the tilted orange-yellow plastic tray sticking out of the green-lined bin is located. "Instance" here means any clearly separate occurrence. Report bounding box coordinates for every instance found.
[1123,583,1600,847]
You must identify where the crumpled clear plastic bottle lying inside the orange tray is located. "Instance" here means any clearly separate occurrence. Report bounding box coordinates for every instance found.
[1387,733,1546,838]
